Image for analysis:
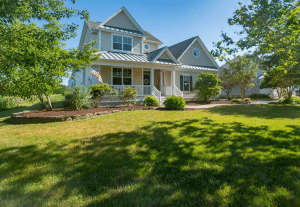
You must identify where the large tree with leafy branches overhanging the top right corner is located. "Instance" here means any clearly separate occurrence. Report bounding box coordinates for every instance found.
[212,0,300,97]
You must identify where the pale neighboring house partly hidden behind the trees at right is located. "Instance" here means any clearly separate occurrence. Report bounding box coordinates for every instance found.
[220,57,277,97]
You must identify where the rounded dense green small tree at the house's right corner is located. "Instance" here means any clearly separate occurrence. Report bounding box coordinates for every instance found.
[195,72,222,101]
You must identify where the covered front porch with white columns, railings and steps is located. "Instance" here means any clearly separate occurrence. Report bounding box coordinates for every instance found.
[88,65,184,102]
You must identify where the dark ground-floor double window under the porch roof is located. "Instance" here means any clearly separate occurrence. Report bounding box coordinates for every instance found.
[113,68,132,85]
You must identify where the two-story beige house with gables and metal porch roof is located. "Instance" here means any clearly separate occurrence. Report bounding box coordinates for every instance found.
[69,7,219,101]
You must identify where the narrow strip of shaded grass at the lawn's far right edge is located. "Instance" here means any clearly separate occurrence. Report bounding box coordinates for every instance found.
[208,104,300,119]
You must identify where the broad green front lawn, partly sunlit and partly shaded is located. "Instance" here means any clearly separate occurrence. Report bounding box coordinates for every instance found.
[0,105,300,207]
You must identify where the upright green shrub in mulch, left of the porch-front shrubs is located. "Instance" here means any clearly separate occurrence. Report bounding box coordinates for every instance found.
[70,86,90,110]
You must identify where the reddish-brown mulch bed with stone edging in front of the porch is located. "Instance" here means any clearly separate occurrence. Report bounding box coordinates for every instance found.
[20,106,157,117]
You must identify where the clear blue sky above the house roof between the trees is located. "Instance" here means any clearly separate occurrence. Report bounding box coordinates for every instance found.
[63,0,247,85]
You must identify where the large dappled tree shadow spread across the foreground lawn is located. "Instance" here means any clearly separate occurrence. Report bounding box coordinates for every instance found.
[0,119,300,206]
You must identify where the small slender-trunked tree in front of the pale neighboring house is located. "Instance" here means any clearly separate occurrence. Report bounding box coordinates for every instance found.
[226,55,258,99]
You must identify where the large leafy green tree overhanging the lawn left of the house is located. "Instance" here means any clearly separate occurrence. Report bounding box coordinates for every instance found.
[0,0,97,110]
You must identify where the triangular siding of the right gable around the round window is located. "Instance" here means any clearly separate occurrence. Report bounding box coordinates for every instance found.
[179,41,215,67]
